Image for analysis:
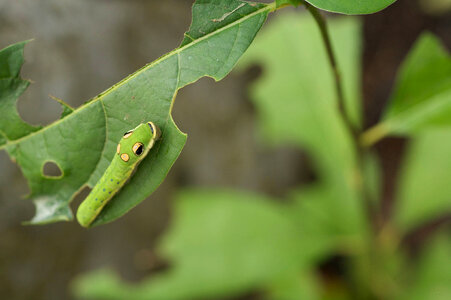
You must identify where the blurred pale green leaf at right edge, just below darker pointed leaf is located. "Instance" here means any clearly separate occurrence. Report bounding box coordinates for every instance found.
[395,129,451,231]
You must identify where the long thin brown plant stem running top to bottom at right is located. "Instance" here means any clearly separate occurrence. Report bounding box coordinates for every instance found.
[294,0,399,299]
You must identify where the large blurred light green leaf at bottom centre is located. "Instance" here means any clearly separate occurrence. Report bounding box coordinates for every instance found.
[75,190,314,300]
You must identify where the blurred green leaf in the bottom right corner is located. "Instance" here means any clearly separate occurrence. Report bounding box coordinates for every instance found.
[399,232,451,300]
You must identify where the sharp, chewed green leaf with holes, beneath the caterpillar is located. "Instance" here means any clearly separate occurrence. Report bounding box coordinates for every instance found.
[0,0,274,225]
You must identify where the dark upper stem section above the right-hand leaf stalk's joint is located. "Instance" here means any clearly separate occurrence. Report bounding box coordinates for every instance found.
[303,1,356,135]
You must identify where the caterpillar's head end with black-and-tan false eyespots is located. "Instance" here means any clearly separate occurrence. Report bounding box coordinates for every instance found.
[116,122,160,164]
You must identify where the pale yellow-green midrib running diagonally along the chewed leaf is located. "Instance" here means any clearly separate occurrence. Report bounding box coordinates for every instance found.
[0,2,276,150]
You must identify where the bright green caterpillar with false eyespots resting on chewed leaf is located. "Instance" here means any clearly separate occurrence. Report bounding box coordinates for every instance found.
[77,122,160,227]
